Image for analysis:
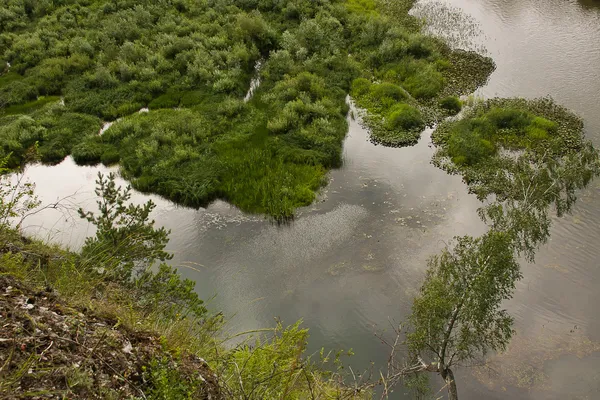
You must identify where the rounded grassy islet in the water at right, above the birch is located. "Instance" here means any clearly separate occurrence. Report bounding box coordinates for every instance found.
[433,98,600,206]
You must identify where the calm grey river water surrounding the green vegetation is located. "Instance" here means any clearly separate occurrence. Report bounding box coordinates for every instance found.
[16,0,600,399]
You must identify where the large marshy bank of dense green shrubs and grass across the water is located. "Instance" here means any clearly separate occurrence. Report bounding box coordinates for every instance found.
[0,0,493,220]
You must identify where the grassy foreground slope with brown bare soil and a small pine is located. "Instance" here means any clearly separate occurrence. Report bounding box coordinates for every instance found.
[0,171,371,400]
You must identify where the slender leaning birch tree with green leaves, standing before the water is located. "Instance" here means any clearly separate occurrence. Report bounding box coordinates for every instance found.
[407,230,521,398]
